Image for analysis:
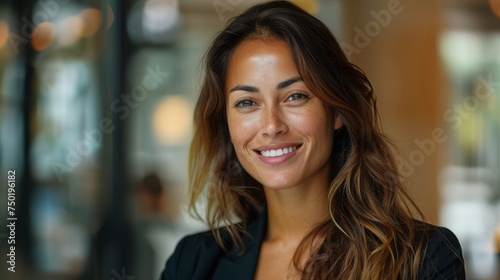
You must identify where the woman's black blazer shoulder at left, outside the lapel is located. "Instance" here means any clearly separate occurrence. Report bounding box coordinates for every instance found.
[161,231,222,280]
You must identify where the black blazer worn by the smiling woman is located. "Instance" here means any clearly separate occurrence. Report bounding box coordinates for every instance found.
[160,211,465,280]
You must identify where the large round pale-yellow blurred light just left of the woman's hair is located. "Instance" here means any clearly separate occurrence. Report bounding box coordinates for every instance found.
[153,96,192,145]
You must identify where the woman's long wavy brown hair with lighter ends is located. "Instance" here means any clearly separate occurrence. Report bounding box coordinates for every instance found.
[189,1,427,279]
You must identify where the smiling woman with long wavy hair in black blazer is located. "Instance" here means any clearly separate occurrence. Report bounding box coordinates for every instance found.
[162,1,465,279]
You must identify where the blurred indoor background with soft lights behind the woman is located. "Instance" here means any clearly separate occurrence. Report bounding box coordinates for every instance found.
[0,0,500,280]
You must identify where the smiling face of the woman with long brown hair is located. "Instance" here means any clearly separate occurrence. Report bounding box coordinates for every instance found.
[225,39,342,189]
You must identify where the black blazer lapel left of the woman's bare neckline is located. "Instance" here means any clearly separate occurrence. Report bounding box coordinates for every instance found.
[213,207,267,280]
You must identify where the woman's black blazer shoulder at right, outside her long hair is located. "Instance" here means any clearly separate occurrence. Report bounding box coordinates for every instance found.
[420,224,465,279]
